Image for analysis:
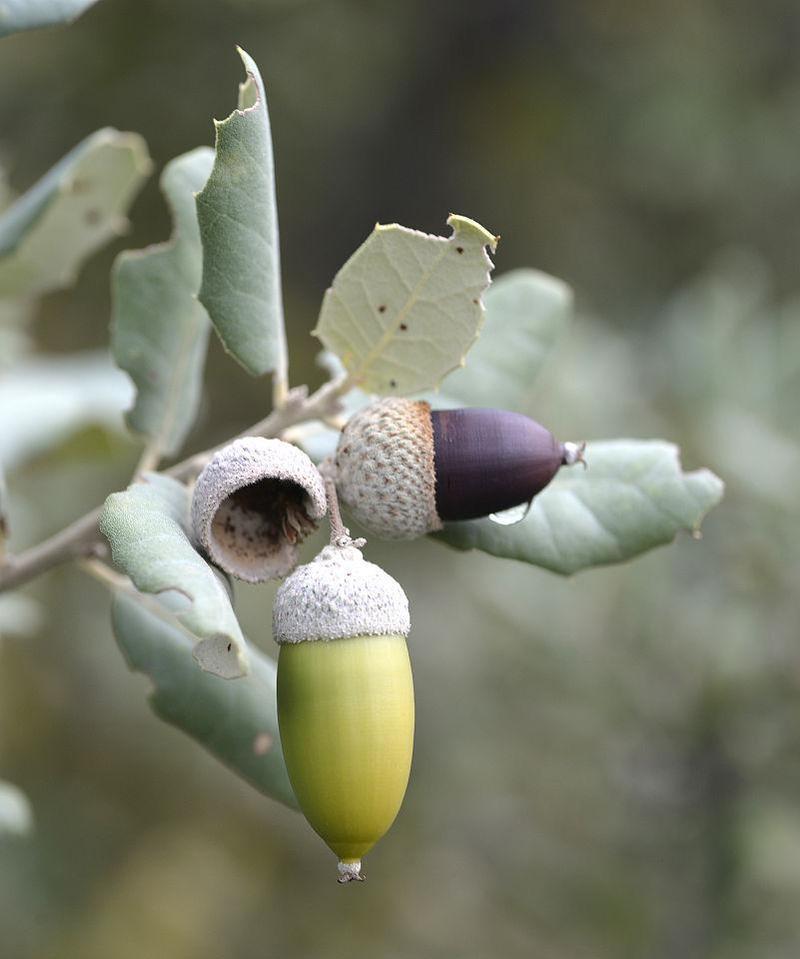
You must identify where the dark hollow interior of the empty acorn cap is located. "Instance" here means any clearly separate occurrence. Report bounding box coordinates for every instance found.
[210,477,317,575]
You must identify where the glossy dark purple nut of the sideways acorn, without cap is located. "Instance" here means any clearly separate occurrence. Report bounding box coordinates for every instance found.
[431,408,565,522]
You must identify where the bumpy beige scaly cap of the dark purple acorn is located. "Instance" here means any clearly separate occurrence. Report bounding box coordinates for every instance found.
[336,398,442,539]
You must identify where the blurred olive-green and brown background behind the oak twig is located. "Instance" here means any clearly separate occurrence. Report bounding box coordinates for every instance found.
[0,0,800,959]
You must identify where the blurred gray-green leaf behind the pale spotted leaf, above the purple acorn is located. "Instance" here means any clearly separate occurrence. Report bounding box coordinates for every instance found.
[444,269,573,411]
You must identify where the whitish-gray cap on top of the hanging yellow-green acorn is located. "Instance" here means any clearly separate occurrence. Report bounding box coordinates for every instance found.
[272,546,411,643]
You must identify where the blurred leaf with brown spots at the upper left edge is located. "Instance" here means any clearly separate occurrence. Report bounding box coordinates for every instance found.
[0,129,152,296]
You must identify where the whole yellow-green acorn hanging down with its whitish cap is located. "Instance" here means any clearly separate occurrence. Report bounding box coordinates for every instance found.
[273,537,414,882]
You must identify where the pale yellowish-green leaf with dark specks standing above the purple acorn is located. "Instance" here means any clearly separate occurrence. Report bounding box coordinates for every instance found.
[314,214,497,396]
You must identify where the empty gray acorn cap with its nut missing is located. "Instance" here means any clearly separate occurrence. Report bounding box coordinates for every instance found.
[192,436,327,583]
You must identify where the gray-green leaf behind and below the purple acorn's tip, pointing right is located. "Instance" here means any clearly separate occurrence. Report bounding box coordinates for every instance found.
[434,440,724,575]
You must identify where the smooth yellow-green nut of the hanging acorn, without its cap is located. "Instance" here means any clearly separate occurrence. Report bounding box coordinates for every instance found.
[278,635,414,864]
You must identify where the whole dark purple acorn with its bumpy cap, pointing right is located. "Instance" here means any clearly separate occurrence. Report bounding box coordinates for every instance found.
[334,398,585,539]
